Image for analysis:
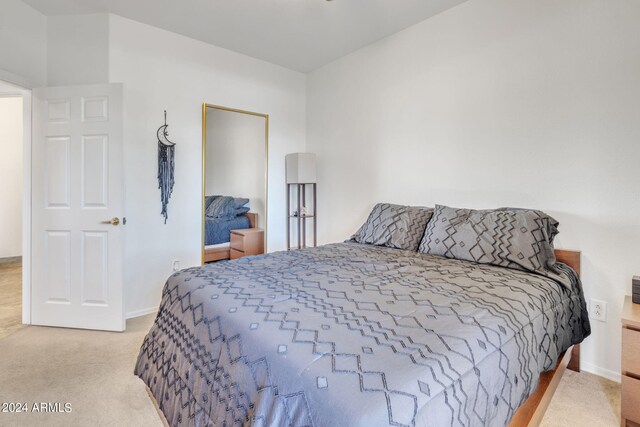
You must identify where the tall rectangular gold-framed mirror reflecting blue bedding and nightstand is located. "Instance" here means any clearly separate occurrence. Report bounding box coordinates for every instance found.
[202,104,269,264]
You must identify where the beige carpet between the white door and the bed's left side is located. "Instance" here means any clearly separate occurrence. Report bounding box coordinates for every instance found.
[0,315,162,427]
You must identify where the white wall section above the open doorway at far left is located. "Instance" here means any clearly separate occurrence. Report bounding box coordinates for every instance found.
[0,0,47,87]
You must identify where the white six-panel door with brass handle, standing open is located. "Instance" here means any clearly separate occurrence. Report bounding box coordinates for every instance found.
[31,84,125,331]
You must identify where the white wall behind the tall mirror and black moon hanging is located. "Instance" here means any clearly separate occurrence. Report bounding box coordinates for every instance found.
[109,15,305,313]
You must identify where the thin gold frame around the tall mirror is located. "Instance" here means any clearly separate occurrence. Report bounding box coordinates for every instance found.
[200,102,269,265]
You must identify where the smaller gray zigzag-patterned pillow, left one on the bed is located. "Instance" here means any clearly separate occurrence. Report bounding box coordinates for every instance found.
[351,203,433,251]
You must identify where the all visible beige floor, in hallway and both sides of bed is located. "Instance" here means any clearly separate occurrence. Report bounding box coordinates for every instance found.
[0,262,620,427]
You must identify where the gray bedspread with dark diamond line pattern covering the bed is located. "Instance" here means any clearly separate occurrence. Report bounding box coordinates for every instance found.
[135,243,590,426]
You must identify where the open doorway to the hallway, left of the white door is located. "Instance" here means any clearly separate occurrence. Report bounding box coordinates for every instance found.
[0,81,31,338]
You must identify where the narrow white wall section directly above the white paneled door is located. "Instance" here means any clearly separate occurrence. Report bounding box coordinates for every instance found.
[47,13,109,86]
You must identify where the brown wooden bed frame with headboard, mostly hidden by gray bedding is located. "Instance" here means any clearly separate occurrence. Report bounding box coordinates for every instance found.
[145,246,580,427]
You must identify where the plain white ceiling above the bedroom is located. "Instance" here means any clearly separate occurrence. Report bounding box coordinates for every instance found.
[23,0,466,72]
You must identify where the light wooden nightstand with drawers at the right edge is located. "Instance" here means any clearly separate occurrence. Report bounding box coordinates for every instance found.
[620,296,640,427]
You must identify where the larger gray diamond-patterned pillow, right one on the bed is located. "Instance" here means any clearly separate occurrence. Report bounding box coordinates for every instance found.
[418,205,569,286]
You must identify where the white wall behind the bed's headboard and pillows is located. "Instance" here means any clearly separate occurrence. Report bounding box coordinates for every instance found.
[307,0,640,378]
